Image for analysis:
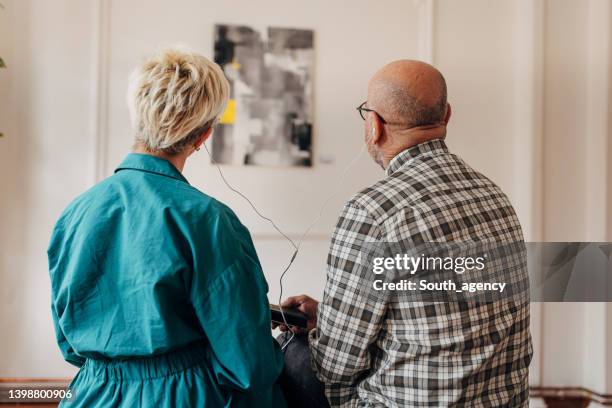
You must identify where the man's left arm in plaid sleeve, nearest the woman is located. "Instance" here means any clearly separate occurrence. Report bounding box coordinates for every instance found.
[310,202,386,406]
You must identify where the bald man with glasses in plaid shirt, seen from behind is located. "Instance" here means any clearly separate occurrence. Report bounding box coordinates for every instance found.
[281,61,532,407]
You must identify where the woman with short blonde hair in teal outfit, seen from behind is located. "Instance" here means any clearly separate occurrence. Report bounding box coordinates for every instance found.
[48,50,285,408]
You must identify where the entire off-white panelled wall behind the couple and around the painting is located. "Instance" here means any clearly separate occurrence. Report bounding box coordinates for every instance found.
[0,0,612,398]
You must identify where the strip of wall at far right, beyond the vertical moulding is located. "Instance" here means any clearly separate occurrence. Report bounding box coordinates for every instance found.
[541,0,612,393]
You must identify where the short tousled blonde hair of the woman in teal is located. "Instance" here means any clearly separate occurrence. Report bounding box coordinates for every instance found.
[128,48,230,154]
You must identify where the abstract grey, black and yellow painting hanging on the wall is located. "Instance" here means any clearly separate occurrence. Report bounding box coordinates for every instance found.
[212,25,314,166]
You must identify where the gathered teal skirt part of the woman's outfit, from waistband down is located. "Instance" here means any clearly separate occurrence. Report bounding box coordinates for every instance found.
[60,344,284,408]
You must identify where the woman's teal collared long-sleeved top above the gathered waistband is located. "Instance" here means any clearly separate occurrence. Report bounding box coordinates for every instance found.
[48,154,284,406]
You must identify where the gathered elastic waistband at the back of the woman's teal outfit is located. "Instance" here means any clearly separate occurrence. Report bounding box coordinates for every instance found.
[82,342,207,380]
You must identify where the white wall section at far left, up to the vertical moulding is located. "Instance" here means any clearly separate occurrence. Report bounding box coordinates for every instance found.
[0,1,94,376]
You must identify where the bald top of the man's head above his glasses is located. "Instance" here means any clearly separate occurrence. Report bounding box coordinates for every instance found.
[368,60,447,127]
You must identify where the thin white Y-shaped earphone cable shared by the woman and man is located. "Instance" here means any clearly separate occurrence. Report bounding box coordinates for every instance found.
[204,143,366,350]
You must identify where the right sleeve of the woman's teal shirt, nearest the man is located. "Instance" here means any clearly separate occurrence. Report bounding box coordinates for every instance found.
[191,206,284,394]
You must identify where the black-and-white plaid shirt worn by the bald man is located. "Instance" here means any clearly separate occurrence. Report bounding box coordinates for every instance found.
[309,140,532,407]
